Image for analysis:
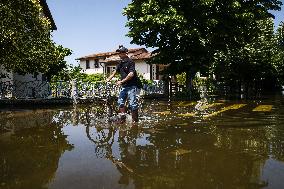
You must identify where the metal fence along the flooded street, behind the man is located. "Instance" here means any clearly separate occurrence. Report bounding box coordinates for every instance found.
[0,80,164,99]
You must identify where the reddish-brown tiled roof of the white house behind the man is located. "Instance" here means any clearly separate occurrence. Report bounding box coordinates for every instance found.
[77,48,151,62]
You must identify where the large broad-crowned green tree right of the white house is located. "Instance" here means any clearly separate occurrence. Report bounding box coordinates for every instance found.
[124,0,282,94]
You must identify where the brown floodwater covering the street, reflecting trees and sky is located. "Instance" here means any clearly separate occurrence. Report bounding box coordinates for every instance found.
[0,95,284,189]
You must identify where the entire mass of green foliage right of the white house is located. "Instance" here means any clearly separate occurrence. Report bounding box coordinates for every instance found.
[124,0,283,94]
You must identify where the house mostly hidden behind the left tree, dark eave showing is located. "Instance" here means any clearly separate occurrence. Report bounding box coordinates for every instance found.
[0,0,57,98]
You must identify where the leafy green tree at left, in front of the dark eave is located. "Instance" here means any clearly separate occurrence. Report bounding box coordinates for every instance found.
[0,0,71,77]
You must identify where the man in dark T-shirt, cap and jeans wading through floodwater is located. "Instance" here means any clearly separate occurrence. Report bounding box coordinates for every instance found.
[106,45,138,122]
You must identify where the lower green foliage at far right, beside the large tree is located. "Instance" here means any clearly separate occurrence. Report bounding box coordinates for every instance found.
[211,19,283,90]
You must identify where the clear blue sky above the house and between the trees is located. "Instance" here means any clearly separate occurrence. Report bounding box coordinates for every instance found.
[47,0,284,65]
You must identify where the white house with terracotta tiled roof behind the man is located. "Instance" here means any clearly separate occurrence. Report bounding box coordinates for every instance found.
[77,48,166,80]
